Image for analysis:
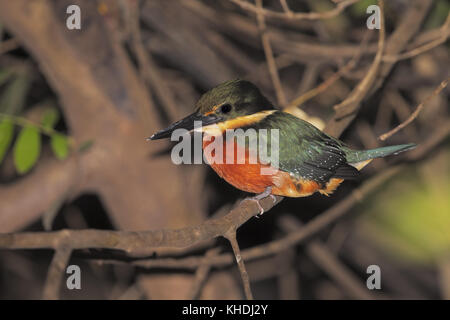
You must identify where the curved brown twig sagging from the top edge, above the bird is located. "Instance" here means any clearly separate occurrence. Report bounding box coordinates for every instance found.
[230,0,359,20]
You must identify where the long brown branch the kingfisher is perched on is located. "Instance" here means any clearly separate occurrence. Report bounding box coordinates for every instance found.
[0,197,282,252]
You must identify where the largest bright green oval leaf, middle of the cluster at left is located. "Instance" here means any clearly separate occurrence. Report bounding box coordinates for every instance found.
[14,126,41,174]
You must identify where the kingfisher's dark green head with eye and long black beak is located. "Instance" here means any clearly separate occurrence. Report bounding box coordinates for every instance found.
[150,79,273,140]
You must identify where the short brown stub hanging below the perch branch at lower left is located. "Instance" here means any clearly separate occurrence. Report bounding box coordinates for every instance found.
[42,247,72,300]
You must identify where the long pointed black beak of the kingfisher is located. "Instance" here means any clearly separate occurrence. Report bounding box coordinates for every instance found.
[147,112,222,140]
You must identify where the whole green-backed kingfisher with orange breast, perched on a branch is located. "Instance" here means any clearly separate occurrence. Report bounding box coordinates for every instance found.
[147,79,416,213]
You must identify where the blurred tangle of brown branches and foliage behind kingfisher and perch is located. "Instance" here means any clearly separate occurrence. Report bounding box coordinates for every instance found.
[0,0,450,299]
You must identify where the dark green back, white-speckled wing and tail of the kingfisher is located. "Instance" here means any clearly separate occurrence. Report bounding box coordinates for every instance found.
[244,111,415,183]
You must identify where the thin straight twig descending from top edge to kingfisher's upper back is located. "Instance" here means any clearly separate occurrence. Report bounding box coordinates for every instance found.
[255,0,287,107]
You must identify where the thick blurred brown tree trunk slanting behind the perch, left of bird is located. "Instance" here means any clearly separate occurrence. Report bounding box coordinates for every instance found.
[0,0,203,231]
